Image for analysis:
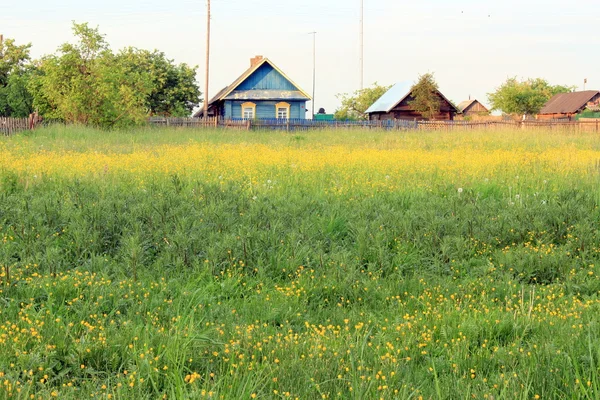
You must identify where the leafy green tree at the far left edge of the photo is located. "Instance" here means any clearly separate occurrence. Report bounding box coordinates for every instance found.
[0,39,33,117]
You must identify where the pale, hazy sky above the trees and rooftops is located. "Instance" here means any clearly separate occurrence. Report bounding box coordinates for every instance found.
[0,0,600,112]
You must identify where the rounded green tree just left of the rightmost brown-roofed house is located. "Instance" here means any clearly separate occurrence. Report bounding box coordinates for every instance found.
[488,77,575,115]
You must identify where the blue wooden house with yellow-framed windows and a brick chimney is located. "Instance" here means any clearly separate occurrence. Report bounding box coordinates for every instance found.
[194,56,311,119]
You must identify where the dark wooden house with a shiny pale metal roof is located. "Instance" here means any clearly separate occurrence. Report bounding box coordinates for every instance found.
[365,82,459,121]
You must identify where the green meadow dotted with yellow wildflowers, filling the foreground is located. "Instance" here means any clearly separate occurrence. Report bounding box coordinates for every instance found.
[0,127,600,399]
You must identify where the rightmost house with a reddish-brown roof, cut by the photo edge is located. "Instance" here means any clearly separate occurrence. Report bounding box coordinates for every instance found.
[537,90,600,120]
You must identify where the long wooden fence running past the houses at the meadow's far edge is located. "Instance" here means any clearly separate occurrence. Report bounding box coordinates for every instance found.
[149,117,600,133]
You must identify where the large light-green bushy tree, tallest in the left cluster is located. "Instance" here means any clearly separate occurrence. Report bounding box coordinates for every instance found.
[30,23,152,127]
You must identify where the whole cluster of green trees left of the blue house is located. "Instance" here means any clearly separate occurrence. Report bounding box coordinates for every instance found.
[0,23,202,128]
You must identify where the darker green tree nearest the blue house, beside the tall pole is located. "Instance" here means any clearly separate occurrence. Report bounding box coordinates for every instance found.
[118,47,202,117]
